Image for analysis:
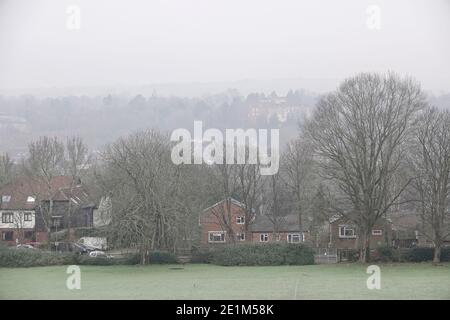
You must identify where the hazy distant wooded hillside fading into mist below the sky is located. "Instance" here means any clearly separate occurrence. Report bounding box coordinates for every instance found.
[0,89,317,159]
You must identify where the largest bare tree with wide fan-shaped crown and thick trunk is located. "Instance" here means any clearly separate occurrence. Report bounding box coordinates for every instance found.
[306,73,425,262]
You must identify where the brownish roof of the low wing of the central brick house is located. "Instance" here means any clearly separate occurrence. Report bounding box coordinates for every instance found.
[249,214,303,232]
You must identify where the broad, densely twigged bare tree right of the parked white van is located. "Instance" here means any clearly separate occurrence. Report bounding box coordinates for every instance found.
[100,131,196,264]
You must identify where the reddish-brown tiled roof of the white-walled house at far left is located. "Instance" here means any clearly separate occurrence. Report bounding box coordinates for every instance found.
[0,176,89,210]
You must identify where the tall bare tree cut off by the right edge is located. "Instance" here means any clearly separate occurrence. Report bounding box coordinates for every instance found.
[411,108,450,264]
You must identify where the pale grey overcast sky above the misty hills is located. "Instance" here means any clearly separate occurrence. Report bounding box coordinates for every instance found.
[0,0,450,93]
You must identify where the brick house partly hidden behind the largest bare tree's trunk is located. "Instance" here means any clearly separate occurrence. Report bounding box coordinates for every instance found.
[321,215,392,249]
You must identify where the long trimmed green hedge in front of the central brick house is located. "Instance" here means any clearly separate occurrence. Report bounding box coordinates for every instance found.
[208,243,314,266]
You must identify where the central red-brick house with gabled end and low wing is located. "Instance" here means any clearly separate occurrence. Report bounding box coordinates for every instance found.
[199,198,307,245]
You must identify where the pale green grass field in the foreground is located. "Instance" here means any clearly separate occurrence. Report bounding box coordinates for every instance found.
[0,263,450,299]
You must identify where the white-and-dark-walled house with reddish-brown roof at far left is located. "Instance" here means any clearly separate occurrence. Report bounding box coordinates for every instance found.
[0,176,96,245]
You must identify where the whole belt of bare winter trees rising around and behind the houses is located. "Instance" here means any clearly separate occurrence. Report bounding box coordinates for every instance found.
[0,73,450,263]
